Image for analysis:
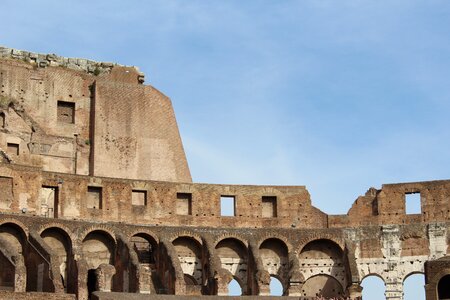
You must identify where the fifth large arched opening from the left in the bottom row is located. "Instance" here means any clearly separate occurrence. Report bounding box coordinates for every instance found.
[172,237,203,295]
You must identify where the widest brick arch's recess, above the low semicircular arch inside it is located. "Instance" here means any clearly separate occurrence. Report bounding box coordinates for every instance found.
[299,239,347,286]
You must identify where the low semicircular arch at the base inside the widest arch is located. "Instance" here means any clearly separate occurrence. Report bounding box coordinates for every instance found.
[302,275,344,298]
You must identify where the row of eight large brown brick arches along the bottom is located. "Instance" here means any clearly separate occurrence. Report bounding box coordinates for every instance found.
[0,222,444,299]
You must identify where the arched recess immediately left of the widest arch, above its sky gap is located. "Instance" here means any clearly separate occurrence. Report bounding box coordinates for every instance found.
[259,238,289,282]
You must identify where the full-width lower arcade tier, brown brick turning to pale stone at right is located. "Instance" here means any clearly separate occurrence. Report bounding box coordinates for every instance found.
[0,214,450,299]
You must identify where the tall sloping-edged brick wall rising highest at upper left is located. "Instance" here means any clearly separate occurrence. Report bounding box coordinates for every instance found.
[0,48,192,182]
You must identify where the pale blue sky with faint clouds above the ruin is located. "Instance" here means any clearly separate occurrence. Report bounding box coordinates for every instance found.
[0,0,450,298]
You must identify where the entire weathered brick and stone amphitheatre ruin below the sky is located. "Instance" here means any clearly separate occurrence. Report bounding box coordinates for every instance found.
[0,48,450,299]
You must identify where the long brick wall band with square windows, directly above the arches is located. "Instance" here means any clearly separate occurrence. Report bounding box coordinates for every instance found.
[0,164,450,229]
